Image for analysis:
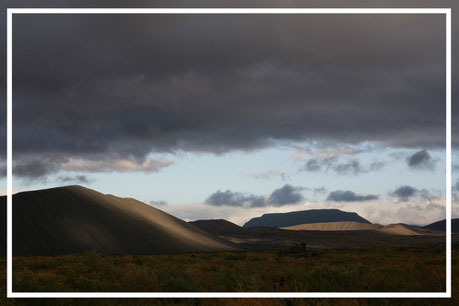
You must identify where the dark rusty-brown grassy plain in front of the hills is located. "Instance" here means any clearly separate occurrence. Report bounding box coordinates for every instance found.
[0,247,459,305]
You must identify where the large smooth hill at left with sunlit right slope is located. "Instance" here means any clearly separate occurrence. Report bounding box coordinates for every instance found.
[0,186,233,256]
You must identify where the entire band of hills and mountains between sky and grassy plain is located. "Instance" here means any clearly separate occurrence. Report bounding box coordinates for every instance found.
[0,186,452,256]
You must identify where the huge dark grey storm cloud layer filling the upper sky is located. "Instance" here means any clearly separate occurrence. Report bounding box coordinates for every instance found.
[2,11,445,170]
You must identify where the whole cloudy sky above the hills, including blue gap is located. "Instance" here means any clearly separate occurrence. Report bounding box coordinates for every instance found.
[0,0,459,225]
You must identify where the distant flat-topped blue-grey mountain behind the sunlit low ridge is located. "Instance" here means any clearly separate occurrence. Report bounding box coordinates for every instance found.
[244,209,371,227]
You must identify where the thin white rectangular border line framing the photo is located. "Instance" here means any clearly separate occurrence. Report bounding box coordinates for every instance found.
[6,8,451,298]
